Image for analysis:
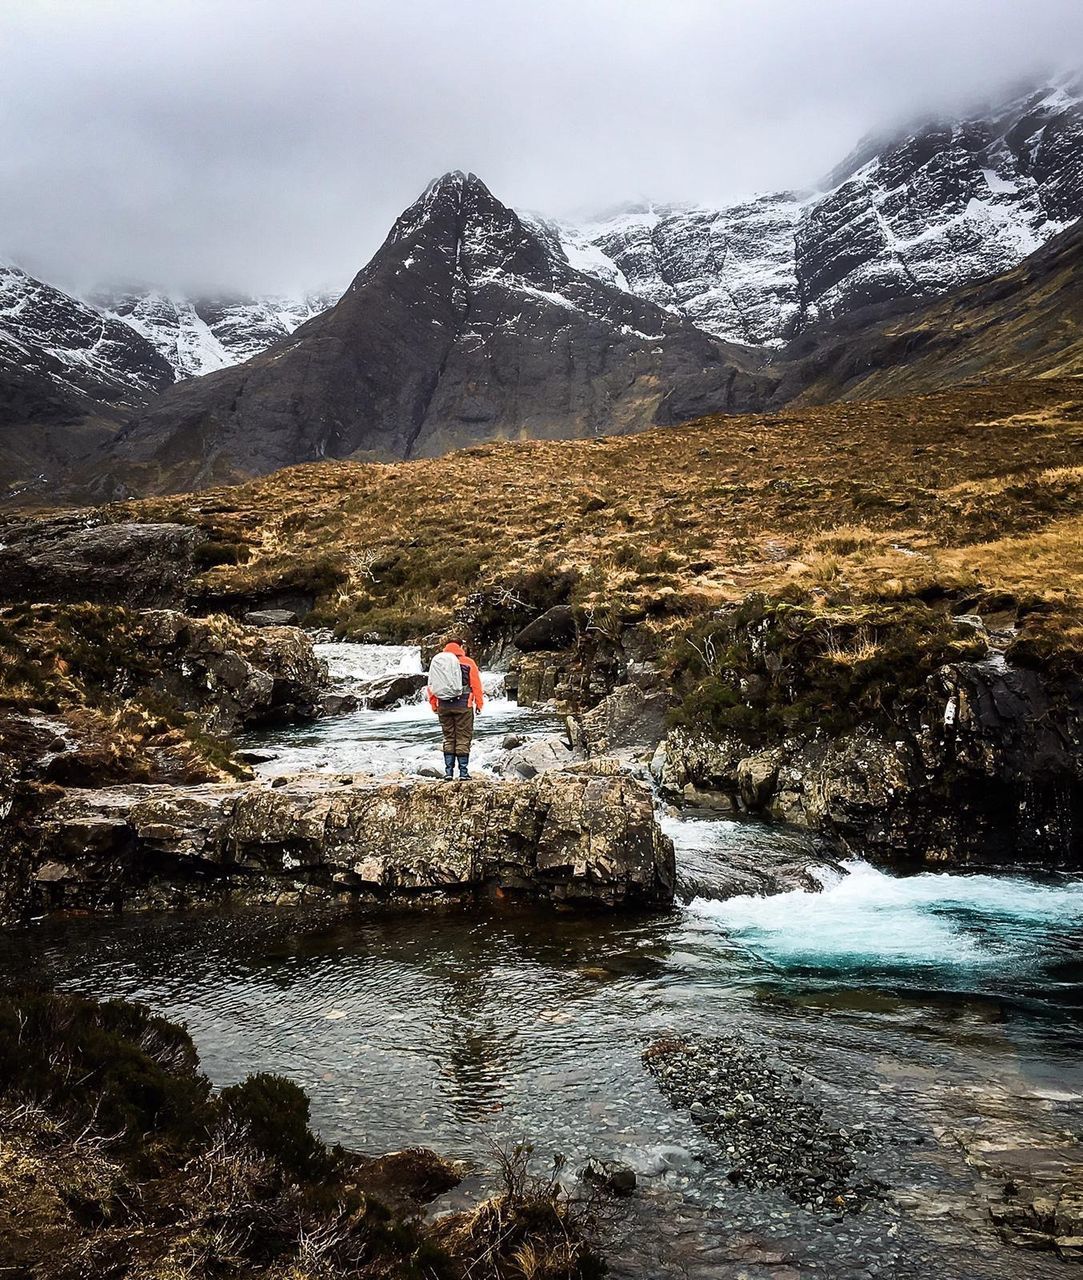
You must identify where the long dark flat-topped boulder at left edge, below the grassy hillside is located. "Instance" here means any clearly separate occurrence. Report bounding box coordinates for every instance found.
[0,516,202,608]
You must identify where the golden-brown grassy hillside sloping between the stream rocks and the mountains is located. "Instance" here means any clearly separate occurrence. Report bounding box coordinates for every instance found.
[114,379,1083,655]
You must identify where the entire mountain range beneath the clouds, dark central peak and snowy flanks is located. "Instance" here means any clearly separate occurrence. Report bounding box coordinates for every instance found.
[0,76,1083,492]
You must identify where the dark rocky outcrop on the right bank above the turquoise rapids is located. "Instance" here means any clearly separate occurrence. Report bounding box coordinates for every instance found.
[653,655,1083,868]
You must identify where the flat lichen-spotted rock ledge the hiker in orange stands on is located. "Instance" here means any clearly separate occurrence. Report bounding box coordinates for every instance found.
[31,773,676,910]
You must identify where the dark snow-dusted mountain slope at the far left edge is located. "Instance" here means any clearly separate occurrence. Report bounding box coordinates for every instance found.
[0,262,173,403]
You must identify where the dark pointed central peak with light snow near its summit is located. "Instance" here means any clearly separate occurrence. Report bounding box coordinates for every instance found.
[97,173,764,489]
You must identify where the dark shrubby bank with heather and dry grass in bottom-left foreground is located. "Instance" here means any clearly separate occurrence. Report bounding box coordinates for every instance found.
[0,991,603,1280]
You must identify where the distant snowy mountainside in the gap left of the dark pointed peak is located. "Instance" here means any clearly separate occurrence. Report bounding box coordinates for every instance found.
[91,289,338,380]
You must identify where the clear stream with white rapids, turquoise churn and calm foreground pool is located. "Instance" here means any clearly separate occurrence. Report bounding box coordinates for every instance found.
[0,644,1083,1280]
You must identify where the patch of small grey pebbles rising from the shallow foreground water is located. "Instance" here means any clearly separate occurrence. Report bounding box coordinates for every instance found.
[643,1036,881,1215]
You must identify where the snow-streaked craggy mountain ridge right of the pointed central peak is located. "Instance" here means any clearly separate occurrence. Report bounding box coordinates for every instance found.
[534,78,1083,346]
